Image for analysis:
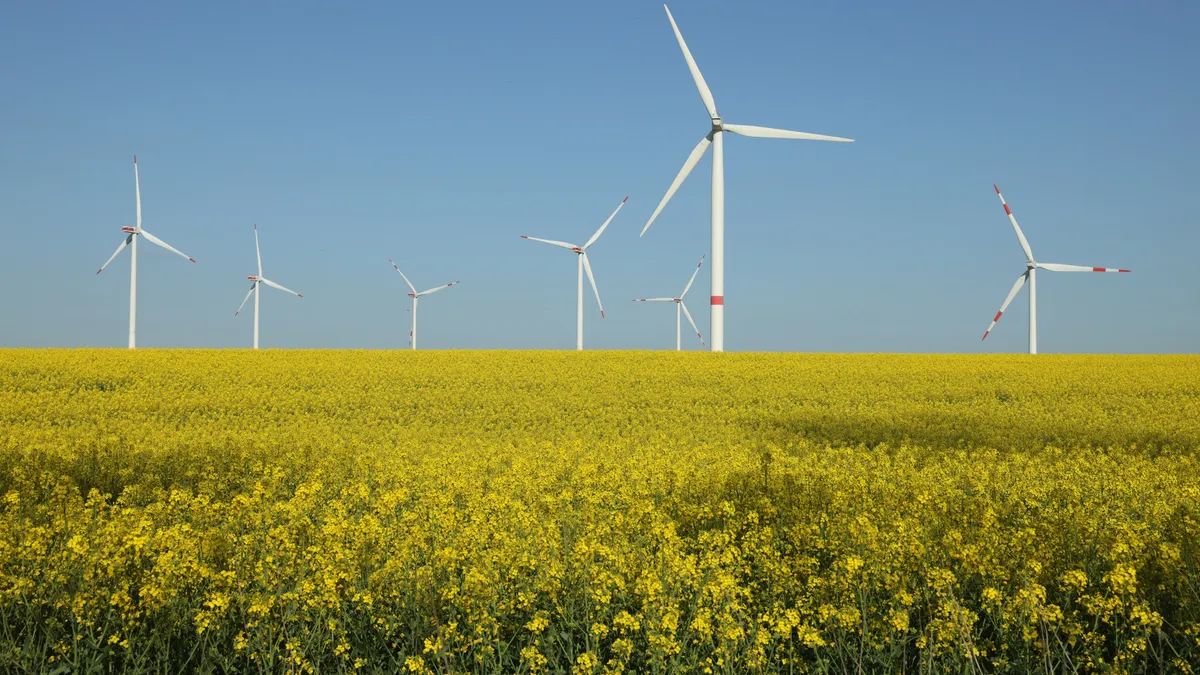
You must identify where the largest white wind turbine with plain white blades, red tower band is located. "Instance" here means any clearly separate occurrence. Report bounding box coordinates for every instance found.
[642,5,853,352]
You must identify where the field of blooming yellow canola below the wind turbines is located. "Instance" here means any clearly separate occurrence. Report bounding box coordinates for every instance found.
[0,350,1200,674]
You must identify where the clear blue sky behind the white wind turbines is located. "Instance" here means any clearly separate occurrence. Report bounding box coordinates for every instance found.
[0,0,1200,352]
